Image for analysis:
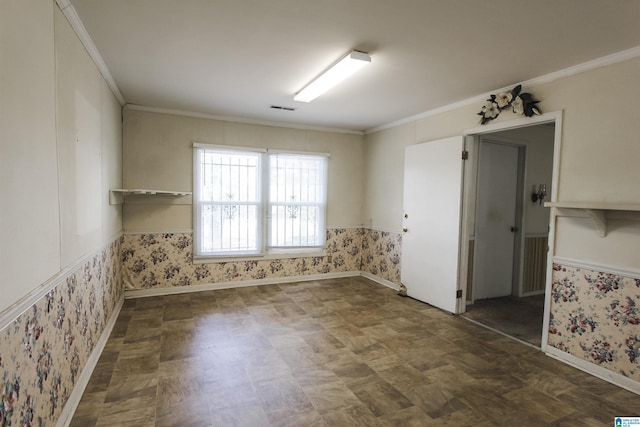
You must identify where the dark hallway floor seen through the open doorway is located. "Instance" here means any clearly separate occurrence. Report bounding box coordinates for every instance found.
[463,294,544,347]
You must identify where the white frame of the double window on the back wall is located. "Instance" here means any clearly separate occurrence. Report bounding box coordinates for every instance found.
[192,142,330,262]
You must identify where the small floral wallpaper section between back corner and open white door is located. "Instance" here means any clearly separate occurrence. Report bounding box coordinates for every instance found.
[360,229,402,285]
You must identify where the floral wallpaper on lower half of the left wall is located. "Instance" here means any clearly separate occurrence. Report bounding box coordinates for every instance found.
[0,238,123,427]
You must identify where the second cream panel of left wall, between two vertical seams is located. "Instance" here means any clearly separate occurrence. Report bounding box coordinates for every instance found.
[55,9,103,267]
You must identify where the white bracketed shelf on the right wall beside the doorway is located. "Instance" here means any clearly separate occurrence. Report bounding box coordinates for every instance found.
[544,202,640,237]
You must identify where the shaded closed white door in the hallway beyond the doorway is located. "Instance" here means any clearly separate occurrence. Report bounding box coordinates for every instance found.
[473,141,518,300]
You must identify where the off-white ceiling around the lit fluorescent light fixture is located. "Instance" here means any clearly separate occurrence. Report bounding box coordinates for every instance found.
[71,0,640,131]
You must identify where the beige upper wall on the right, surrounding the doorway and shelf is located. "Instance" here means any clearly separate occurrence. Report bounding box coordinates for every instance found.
[364,58,640,271]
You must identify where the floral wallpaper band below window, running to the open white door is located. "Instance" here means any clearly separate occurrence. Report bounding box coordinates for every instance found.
[122,228,399,289]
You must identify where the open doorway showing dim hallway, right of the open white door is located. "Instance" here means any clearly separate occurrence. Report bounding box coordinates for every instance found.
[465,122,555,348]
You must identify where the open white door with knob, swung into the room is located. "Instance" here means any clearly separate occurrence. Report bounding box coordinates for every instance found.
[401,136,464,313]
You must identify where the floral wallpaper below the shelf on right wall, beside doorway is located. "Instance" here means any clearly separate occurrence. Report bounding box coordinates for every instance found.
[549,264,640,381]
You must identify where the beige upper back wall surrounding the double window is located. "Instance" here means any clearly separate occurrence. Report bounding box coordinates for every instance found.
[123,108,364,232]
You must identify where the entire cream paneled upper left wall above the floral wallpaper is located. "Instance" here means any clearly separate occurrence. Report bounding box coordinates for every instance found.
[0,0,122,313]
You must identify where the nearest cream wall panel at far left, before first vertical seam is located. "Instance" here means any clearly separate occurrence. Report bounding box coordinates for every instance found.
[0,0,60,311]
